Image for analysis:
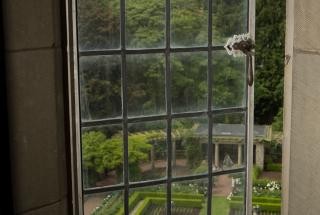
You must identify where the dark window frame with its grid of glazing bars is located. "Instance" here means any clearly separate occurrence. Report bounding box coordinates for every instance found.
[67,0,255,215]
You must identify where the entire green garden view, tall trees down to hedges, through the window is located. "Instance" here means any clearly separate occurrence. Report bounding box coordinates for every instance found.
[78,0,285,212]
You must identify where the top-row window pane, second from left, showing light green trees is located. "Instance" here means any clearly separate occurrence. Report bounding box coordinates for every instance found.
[126,0,165,48]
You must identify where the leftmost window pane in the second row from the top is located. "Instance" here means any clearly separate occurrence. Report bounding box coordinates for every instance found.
[80,56,122,121]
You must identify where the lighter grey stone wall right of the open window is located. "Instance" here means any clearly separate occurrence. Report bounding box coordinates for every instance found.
[282,0,320,215]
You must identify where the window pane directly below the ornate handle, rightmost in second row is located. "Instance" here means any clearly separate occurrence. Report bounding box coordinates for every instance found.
[212,51,246,108]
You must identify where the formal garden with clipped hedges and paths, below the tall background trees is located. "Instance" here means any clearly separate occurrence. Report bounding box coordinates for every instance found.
[83,120,281,215]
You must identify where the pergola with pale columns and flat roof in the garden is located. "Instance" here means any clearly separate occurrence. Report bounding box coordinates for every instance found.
[135,124,272,169]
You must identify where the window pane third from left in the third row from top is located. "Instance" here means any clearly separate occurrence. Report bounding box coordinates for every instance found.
[172,117,208,176]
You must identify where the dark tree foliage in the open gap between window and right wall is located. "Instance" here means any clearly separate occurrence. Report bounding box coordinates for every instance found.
[255,0,286,125]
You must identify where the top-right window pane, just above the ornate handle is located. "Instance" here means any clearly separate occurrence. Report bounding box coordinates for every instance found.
[212,0,248,45]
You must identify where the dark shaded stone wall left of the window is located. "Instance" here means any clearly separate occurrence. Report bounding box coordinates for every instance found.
[2,0,67,215]
